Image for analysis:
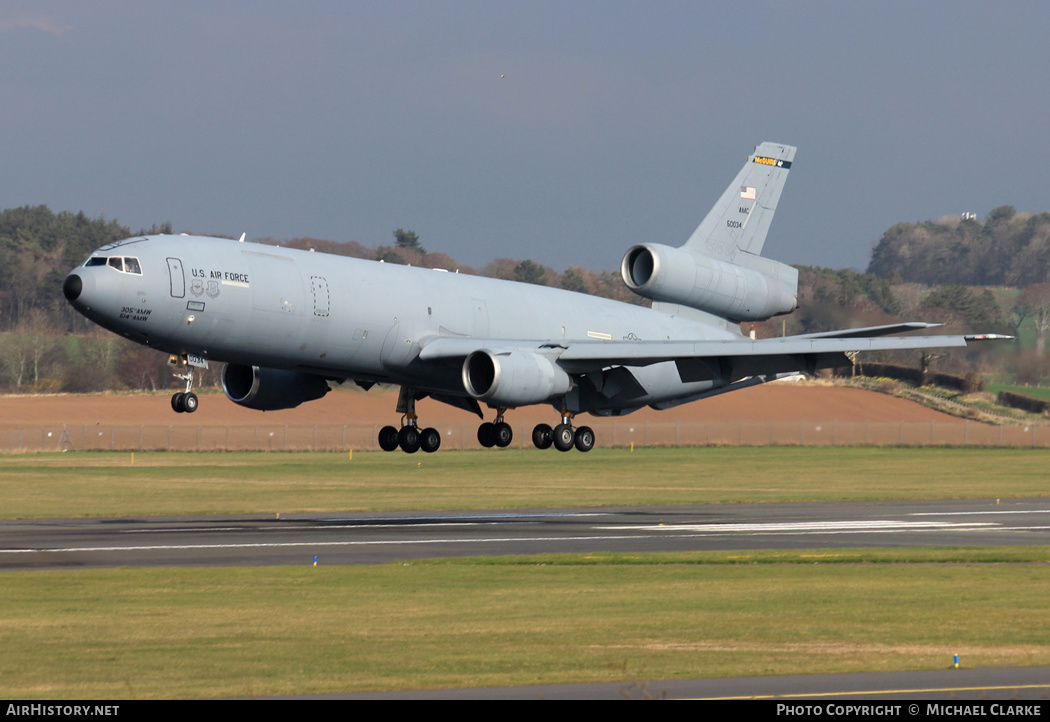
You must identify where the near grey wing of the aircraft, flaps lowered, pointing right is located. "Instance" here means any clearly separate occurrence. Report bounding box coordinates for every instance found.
[420,333,1006,382]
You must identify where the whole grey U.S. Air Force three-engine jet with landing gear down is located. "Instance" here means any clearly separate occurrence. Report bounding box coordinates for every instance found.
[63,143,990,453]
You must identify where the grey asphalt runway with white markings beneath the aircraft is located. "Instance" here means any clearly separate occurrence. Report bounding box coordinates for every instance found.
[0,498,1050,570]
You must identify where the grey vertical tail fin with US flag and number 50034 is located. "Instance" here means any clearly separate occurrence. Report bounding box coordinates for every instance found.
[683,143,795,257]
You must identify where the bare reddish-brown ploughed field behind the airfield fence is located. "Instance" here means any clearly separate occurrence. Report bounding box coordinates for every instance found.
[0,383,962,426]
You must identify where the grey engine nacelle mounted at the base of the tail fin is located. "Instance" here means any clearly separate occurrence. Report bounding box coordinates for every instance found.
[620,243,798,321]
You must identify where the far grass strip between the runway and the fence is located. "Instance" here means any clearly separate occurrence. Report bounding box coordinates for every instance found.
[0,447,1050,518]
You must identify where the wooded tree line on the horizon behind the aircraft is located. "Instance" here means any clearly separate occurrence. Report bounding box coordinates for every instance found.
[0,206,1050,391]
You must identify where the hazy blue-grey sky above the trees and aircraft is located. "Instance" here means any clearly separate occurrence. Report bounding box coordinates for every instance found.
[0,0,1050,271]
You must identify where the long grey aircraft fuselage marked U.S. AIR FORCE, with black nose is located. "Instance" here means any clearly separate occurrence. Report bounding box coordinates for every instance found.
[67,236,740,412]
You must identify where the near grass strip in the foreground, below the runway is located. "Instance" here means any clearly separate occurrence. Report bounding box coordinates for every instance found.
[0,548,1050,699]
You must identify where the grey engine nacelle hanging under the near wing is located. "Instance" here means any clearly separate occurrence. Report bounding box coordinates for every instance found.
[463,349,572,406]
